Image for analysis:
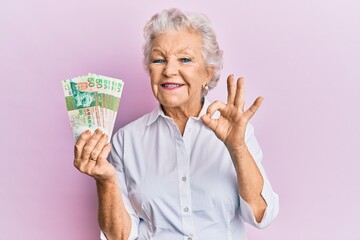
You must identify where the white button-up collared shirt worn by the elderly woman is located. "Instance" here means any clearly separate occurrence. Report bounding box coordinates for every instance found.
[101,101,279,240]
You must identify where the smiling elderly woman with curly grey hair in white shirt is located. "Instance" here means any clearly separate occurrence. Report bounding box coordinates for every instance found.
[74,9,278,240]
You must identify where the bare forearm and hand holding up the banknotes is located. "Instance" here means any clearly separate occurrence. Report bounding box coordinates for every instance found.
[74,129,131,240]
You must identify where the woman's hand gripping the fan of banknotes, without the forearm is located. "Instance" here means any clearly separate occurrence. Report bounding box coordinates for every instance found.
[74,129,116,182]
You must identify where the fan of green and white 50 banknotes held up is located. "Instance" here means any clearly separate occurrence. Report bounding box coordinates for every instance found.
[62,73,124,140]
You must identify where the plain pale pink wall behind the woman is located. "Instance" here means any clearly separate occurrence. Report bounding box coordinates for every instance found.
[0,0,360,240]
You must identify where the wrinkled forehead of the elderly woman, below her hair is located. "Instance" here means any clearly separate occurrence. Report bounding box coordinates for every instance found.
[151,30,202,54]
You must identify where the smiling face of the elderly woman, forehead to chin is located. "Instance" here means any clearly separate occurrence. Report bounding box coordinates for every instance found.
[149,31,212,109]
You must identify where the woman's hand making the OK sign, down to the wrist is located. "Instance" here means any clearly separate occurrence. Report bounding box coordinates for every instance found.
[202,75,263,153]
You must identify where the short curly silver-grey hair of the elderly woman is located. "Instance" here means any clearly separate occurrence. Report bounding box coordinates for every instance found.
[144,8,223,96]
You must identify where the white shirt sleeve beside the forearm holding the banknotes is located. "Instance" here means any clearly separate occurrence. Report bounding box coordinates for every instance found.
[100,130,140,240]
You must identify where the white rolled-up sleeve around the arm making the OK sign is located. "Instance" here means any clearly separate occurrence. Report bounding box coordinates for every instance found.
[239,124,279,228]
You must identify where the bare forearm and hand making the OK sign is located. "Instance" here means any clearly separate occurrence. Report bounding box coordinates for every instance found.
[202,75,267,222]
